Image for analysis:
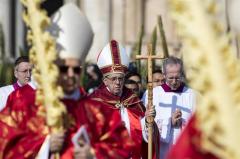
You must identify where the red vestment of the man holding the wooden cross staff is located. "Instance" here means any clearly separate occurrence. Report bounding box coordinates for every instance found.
[89,84,159,159]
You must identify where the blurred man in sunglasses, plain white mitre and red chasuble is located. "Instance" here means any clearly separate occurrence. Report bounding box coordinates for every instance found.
[0,3,135,159]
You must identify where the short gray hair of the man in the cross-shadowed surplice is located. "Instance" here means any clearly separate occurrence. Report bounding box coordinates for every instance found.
[163,56,185,77]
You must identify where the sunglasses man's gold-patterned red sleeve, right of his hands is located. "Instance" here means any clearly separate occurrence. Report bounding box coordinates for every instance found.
[80,100,134,159]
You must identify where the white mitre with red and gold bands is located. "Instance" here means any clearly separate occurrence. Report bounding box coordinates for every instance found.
[97,40,129,76]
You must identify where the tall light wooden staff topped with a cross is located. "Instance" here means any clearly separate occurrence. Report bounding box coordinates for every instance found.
[136,44,164,159]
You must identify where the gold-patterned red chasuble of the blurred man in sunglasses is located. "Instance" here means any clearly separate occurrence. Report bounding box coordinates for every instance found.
[0,85,133,159]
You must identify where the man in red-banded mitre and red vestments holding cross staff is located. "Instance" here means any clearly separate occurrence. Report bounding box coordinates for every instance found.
[89,40,158,159]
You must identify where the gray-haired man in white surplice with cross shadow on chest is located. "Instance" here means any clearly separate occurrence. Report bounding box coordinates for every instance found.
[143,56,196,158]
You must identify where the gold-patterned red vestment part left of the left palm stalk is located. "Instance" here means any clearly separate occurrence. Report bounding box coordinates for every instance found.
[0,86,45,159]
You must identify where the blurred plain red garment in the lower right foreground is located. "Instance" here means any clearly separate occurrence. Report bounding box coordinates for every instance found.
[167,116,217,159]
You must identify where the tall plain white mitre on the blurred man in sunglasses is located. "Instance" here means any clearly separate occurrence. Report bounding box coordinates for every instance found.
[48,3,93,64]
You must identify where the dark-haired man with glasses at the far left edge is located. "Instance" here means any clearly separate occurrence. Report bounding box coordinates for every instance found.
[0,56,33,110]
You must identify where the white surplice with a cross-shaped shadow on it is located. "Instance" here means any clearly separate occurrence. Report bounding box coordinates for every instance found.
[142,86,197,159]
